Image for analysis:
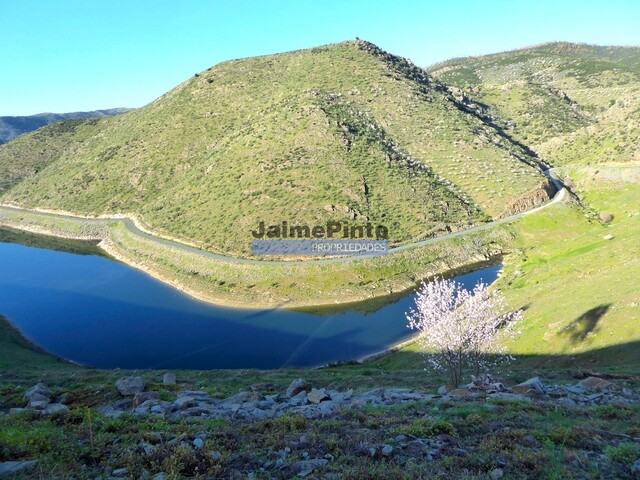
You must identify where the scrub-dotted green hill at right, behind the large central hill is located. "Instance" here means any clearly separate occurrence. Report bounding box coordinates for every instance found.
[428,43,640,169]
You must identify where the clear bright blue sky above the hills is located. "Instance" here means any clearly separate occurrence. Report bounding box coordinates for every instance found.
[0,0,640,115]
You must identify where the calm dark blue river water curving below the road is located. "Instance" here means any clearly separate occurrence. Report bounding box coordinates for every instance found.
[0,231,500,369]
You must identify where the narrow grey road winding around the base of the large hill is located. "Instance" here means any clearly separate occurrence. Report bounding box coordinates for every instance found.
[0,169,566,265]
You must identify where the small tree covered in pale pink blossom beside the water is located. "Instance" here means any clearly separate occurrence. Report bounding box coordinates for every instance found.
[407,279,522,386]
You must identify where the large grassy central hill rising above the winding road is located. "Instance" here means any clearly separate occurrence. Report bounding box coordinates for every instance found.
[0,41,549,255]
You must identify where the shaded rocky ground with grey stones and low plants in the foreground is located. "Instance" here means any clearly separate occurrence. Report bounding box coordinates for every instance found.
[0,374,640,480]
